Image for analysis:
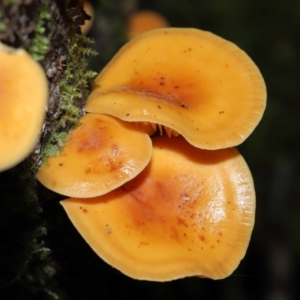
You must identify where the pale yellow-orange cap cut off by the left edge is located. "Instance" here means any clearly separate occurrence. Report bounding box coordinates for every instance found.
[0,43,48,171]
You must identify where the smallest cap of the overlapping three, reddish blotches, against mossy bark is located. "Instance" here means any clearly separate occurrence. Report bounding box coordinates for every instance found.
[37,114,152,198]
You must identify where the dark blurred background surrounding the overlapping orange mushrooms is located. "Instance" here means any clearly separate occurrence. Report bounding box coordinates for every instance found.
[45,0,300,300]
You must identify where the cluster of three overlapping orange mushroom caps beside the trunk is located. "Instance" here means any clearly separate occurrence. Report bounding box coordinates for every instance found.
[0,28,266,281]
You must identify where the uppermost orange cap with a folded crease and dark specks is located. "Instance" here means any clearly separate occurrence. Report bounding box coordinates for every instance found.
[86,28,266,149]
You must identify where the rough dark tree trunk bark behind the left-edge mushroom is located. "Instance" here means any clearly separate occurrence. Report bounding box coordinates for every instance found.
[0,0,88,299]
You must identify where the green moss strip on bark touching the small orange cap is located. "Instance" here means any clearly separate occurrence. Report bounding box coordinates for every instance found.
[41,33,96,161]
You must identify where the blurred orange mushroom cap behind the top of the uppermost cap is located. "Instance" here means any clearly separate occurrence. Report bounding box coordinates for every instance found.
[126,10,169,39]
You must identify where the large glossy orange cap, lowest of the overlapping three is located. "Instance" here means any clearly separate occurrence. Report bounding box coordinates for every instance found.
[61,136,255,281]
